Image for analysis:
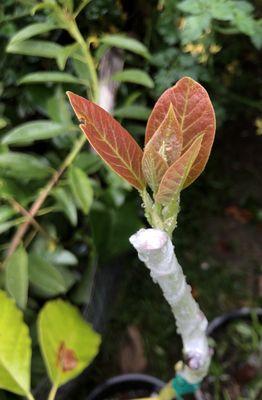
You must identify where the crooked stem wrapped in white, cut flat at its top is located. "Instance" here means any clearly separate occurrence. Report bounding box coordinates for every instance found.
[130,229,211,384]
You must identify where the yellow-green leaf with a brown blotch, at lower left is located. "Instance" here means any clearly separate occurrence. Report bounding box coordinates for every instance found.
[38,300,101,386]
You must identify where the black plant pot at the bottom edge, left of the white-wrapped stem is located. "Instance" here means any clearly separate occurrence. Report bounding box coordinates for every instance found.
[86,374,164,400]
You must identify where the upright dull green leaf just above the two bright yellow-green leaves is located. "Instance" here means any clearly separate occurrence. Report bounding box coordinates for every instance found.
[5,246,28,309]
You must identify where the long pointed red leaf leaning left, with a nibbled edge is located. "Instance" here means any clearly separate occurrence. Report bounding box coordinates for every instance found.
[67,92,145,190]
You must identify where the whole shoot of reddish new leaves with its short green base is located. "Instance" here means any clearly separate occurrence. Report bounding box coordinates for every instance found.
[68,77,215,235]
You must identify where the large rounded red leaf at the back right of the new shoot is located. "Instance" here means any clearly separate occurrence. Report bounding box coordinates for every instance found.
[146,77,215,187]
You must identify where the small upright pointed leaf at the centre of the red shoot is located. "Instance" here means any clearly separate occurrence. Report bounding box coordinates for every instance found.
[146,103,183,165]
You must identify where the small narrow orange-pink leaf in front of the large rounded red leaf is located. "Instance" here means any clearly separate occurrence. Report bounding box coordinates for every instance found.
[156,135,203,205]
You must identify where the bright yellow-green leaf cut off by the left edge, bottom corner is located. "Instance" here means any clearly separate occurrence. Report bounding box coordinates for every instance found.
[0,291,31,395]
